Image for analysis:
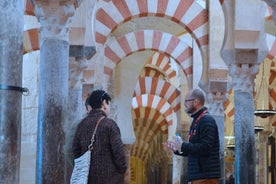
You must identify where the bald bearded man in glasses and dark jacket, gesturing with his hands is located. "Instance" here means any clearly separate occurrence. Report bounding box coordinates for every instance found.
[163,89,220,184]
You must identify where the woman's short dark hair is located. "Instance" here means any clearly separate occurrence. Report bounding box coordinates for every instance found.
[86,89,111,109]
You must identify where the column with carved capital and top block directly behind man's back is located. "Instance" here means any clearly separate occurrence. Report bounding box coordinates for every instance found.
[206,88,227,183]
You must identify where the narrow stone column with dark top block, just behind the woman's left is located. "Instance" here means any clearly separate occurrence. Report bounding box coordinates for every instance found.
[64,45,95,183]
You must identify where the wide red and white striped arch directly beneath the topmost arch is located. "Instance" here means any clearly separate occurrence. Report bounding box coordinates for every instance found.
[104,30,192,87]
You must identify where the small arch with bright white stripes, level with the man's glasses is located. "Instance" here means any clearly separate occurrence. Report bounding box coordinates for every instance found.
[132,94,173,127]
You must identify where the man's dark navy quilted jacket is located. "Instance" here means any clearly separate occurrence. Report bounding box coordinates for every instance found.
[175,107,220,181]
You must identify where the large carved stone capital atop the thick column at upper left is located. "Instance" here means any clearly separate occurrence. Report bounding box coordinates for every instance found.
[31,0,82,45]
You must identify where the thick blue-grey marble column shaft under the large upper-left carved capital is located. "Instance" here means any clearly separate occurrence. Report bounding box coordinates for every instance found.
[36,39,69,184]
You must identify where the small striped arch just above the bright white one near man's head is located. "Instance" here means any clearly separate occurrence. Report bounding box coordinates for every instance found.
[133,77,181,112]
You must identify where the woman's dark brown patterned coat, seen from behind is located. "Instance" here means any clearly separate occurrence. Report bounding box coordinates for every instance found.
[72,110,127,184]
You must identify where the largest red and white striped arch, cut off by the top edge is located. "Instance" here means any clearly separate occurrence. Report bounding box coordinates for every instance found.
[95,0,208,48]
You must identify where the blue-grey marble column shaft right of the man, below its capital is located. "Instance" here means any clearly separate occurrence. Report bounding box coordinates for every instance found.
[234,91,256,184]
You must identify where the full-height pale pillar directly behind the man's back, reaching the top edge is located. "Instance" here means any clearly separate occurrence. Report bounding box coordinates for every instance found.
[204,1,228,183]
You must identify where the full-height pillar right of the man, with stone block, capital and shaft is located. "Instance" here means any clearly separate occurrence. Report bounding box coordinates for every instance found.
[221,0,267,184]
